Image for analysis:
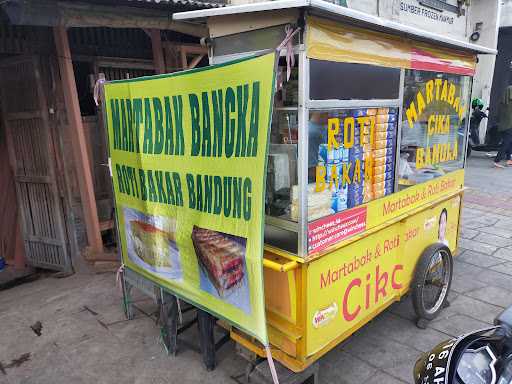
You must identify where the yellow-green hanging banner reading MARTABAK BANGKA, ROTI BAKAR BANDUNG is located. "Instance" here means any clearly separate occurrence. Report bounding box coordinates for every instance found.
[104,53,276,345]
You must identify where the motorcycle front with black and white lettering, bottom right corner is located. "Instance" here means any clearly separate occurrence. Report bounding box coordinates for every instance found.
[414,306,512,384]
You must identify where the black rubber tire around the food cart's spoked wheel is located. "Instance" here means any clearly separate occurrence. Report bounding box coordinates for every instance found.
[411,243,453,321]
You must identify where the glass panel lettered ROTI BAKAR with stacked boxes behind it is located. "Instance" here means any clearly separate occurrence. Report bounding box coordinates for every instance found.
[308,108,398,221]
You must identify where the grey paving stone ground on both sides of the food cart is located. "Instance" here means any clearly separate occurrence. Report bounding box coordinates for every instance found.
[0,154,512,384]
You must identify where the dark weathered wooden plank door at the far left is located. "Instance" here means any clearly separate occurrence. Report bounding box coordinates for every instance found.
[0,57,71,271]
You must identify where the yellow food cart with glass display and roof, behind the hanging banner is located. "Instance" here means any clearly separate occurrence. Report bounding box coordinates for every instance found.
[168,0,494,371]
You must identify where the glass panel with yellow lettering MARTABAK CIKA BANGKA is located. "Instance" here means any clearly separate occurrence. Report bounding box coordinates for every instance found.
[398,70,471,186]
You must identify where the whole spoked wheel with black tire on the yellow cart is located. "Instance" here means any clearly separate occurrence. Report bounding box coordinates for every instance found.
[412,244,453,320]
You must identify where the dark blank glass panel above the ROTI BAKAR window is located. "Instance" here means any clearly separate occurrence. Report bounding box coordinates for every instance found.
[309,60,400,100]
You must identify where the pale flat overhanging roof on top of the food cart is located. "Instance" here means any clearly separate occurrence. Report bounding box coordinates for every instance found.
[173,0,497,55]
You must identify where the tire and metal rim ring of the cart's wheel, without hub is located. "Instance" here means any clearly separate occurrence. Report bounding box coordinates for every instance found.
[411,243,453,321]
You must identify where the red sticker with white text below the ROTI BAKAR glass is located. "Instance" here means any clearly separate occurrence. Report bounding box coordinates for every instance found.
[308,207,366,254]
